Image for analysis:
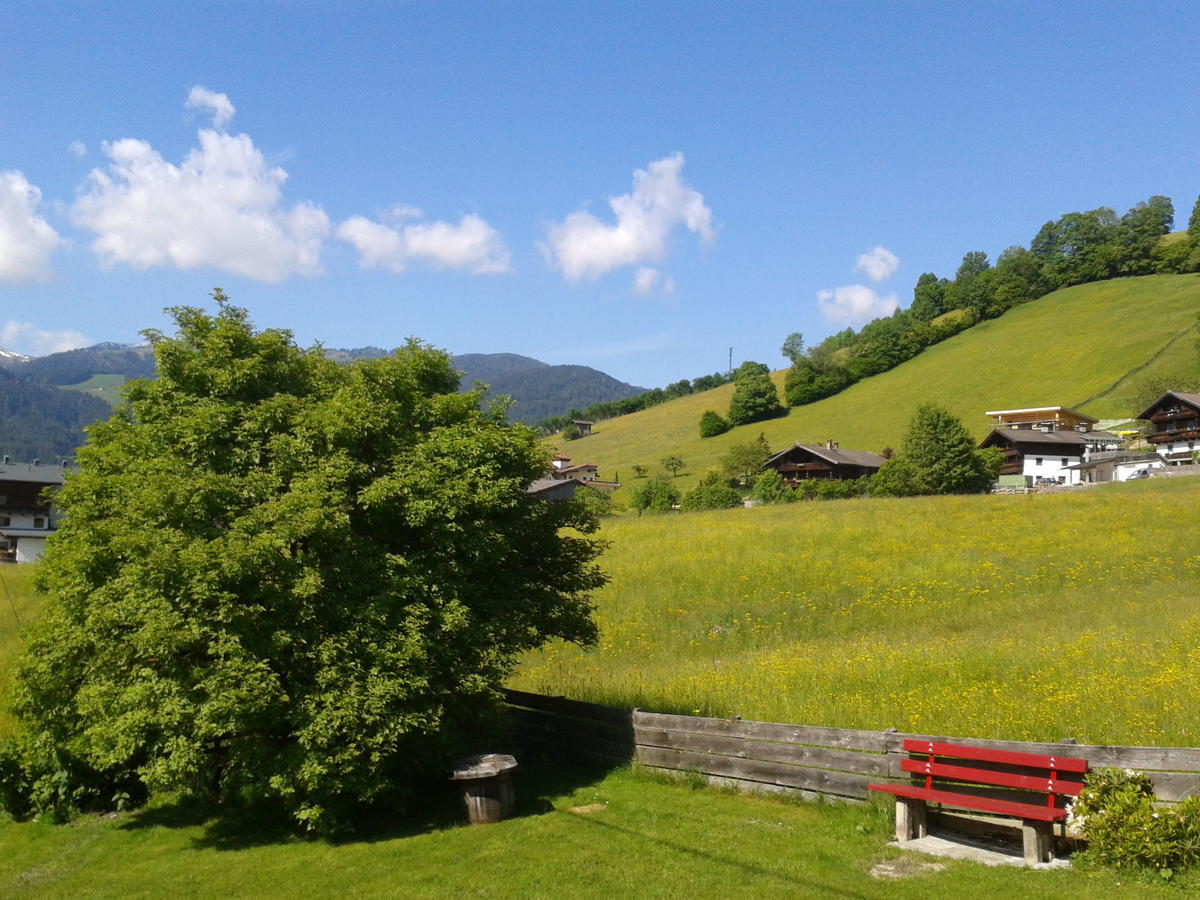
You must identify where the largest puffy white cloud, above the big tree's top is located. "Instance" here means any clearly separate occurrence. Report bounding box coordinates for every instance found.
[74,112,330,282]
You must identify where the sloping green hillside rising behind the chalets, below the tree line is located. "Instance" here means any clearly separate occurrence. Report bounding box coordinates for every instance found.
[560,275,1200,494]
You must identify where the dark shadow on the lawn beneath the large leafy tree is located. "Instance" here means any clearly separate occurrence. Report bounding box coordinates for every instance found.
[120,755,617,851]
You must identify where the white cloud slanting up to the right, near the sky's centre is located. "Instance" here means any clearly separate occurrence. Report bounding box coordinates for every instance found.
[542,154,715,282]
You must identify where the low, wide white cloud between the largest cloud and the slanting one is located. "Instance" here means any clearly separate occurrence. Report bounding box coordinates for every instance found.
[337,206,509,275]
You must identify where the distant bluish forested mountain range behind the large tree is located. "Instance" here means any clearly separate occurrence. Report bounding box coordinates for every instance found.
[0,343,644,461]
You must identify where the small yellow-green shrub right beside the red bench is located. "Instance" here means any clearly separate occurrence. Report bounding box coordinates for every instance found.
[1068,769,1200,877]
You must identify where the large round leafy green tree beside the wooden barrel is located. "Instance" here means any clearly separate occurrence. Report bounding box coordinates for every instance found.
[7,300,604,830]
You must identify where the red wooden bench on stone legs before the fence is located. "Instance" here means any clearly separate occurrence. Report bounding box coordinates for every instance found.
[868,739,1087,865]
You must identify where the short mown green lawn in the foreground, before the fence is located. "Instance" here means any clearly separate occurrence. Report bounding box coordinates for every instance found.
[0,767,1180,900]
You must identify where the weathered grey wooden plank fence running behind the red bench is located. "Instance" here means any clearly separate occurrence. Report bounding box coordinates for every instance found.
[508,691,1200,803]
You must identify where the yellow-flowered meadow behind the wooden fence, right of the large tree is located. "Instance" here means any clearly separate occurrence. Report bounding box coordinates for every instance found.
[512,478,1200,746]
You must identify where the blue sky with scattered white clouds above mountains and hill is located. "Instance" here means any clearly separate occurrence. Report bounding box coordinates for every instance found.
[0,0,1200,386]
